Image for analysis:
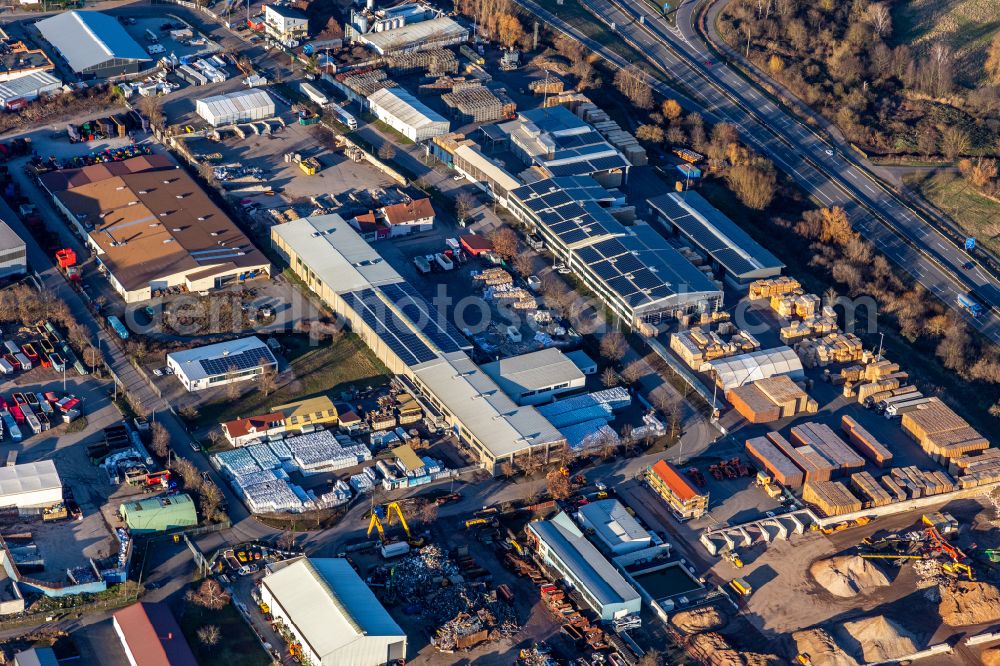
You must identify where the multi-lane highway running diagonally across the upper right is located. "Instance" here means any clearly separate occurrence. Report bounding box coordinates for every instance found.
[517,0,1000,342]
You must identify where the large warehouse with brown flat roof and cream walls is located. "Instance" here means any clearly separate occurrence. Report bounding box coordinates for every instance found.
[40,155,271,303]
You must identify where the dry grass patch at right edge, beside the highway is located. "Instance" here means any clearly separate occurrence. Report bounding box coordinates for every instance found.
[905,172,1000,253]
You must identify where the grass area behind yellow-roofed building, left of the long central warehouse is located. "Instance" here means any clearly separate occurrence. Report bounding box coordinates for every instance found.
[199,332,389,424]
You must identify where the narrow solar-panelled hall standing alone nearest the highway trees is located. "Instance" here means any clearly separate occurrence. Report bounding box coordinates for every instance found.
[649,190,785,288]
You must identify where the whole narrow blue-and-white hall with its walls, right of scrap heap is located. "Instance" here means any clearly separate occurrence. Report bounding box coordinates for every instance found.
[528,512,642,622]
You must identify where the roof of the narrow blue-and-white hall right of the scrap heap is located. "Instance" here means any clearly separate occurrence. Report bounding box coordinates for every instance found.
[528,512,639,605]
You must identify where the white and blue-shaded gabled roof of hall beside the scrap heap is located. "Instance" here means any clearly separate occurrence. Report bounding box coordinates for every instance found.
[264,557,406,659]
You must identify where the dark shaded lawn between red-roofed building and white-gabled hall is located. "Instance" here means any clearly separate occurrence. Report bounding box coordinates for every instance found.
[180,603,272,666]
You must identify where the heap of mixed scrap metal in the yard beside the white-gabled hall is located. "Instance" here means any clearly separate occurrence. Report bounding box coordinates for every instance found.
[386,545,520,652]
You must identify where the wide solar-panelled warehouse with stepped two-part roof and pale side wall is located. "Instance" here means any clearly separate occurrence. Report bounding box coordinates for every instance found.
[507,176,723,327]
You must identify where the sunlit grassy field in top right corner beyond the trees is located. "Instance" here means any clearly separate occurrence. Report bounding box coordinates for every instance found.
[892,0,1000,84]
